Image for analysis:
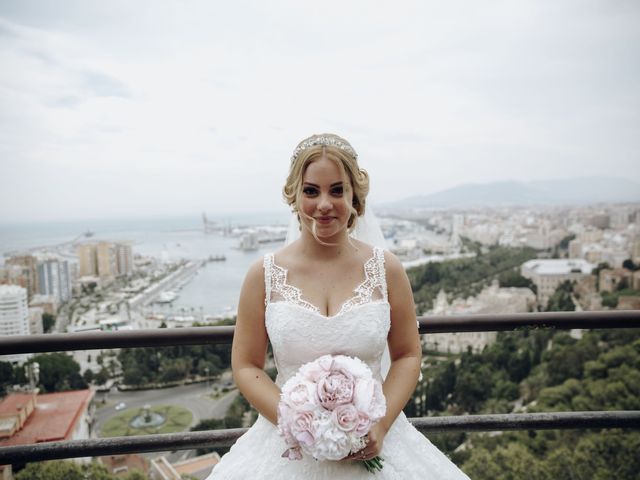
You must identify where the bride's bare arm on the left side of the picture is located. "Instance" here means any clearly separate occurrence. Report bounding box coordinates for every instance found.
[231,261,280,424]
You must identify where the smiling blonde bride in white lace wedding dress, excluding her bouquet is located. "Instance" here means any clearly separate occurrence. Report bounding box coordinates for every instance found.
[209,134,468,480]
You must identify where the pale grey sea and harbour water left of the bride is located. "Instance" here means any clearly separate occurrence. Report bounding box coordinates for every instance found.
[0,210,289,317]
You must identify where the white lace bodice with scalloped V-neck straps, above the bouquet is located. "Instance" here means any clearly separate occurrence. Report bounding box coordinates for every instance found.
[264,247,390,386]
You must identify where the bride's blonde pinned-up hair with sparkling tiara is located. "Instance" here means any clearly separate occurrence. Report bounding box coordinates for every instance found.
[282,133,369,243]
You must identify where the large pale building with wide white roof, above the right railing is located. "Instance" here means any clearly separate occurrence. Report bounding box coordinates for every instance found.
[520,258,596,307]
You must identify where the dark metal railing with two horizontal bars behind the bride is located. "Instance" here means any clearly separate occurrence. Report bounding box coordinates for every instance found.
[0,310,640,464]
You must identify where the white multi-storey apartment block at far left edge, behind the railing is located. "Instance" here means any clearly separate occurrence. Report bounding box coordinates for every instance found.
[0,285,30,362]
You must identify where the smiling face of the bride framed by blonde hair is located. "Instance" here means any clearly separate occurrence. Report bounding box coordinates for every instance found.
[300,156,353,241]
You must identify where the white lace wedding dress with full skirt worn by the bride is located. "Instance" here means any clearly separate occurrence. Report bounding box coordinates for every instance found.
[207,247,469,480]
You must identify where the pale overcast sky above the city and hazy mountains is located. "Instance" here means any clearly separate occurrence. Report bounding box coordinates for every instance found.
[0,0,640,223]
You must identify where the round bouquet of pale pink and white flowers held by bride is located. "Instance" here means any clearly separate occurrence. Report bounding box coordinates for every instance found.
[278,355,386,472]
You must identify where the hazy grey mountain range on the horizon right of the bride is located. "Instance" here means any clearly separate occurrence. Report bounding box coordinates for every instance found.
[381,177,640,209]
